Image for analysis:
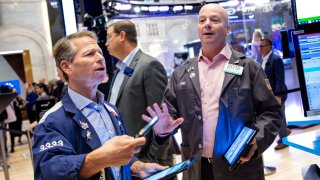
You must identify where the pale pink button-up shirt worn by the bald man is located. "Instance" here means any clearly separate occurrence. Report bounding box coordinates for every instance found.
[198,44,232,157]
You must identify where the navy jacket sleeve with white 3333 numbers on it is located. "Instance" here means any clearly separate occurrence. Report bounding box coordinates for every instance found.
[32,116,86,180]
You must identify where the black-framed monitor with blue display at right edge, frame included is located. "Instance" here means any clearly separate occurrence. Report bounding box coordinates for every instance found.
[293,30,320,116]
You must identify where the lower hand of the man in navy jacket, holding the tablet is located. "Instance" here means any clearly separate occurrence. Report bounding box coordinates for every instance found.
[130,161,168,178]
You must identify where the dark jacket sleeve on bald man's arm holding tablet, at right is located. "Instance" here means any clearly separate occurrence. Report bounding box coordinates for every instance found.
[251,64,282,155]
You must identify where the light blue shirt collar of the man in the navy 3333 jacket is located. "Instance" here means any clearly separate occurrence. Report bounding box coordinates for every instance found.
[68,87,104,111]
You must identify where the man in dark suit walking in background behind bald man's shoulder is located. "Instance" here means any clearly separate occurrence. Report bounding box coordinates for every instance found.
[259,39,290,150]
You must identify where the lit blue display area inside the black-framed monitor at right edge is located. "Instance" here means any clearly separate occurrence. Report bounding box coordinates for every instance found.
[298,33,320,116]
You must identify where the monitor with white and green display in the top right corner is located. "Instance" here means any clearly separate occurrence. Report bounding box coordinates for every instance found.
[291,0,320,30]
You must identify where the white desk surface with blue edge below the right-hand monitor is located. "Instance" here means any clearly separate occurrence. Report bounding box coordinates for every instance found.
[282,130,320,156]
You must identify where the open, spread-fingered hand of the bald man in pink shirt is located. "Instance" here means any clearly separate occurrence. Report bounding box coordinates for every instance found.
[142,103,183,135]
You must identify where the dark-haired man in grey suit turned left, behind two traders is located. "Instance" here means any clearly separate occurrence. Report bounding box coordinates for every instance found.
[106,21,173,165]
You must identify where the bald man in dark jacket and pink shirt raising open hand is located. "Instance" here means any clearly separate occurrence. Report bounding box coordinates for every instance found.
[143,4,281,180]
